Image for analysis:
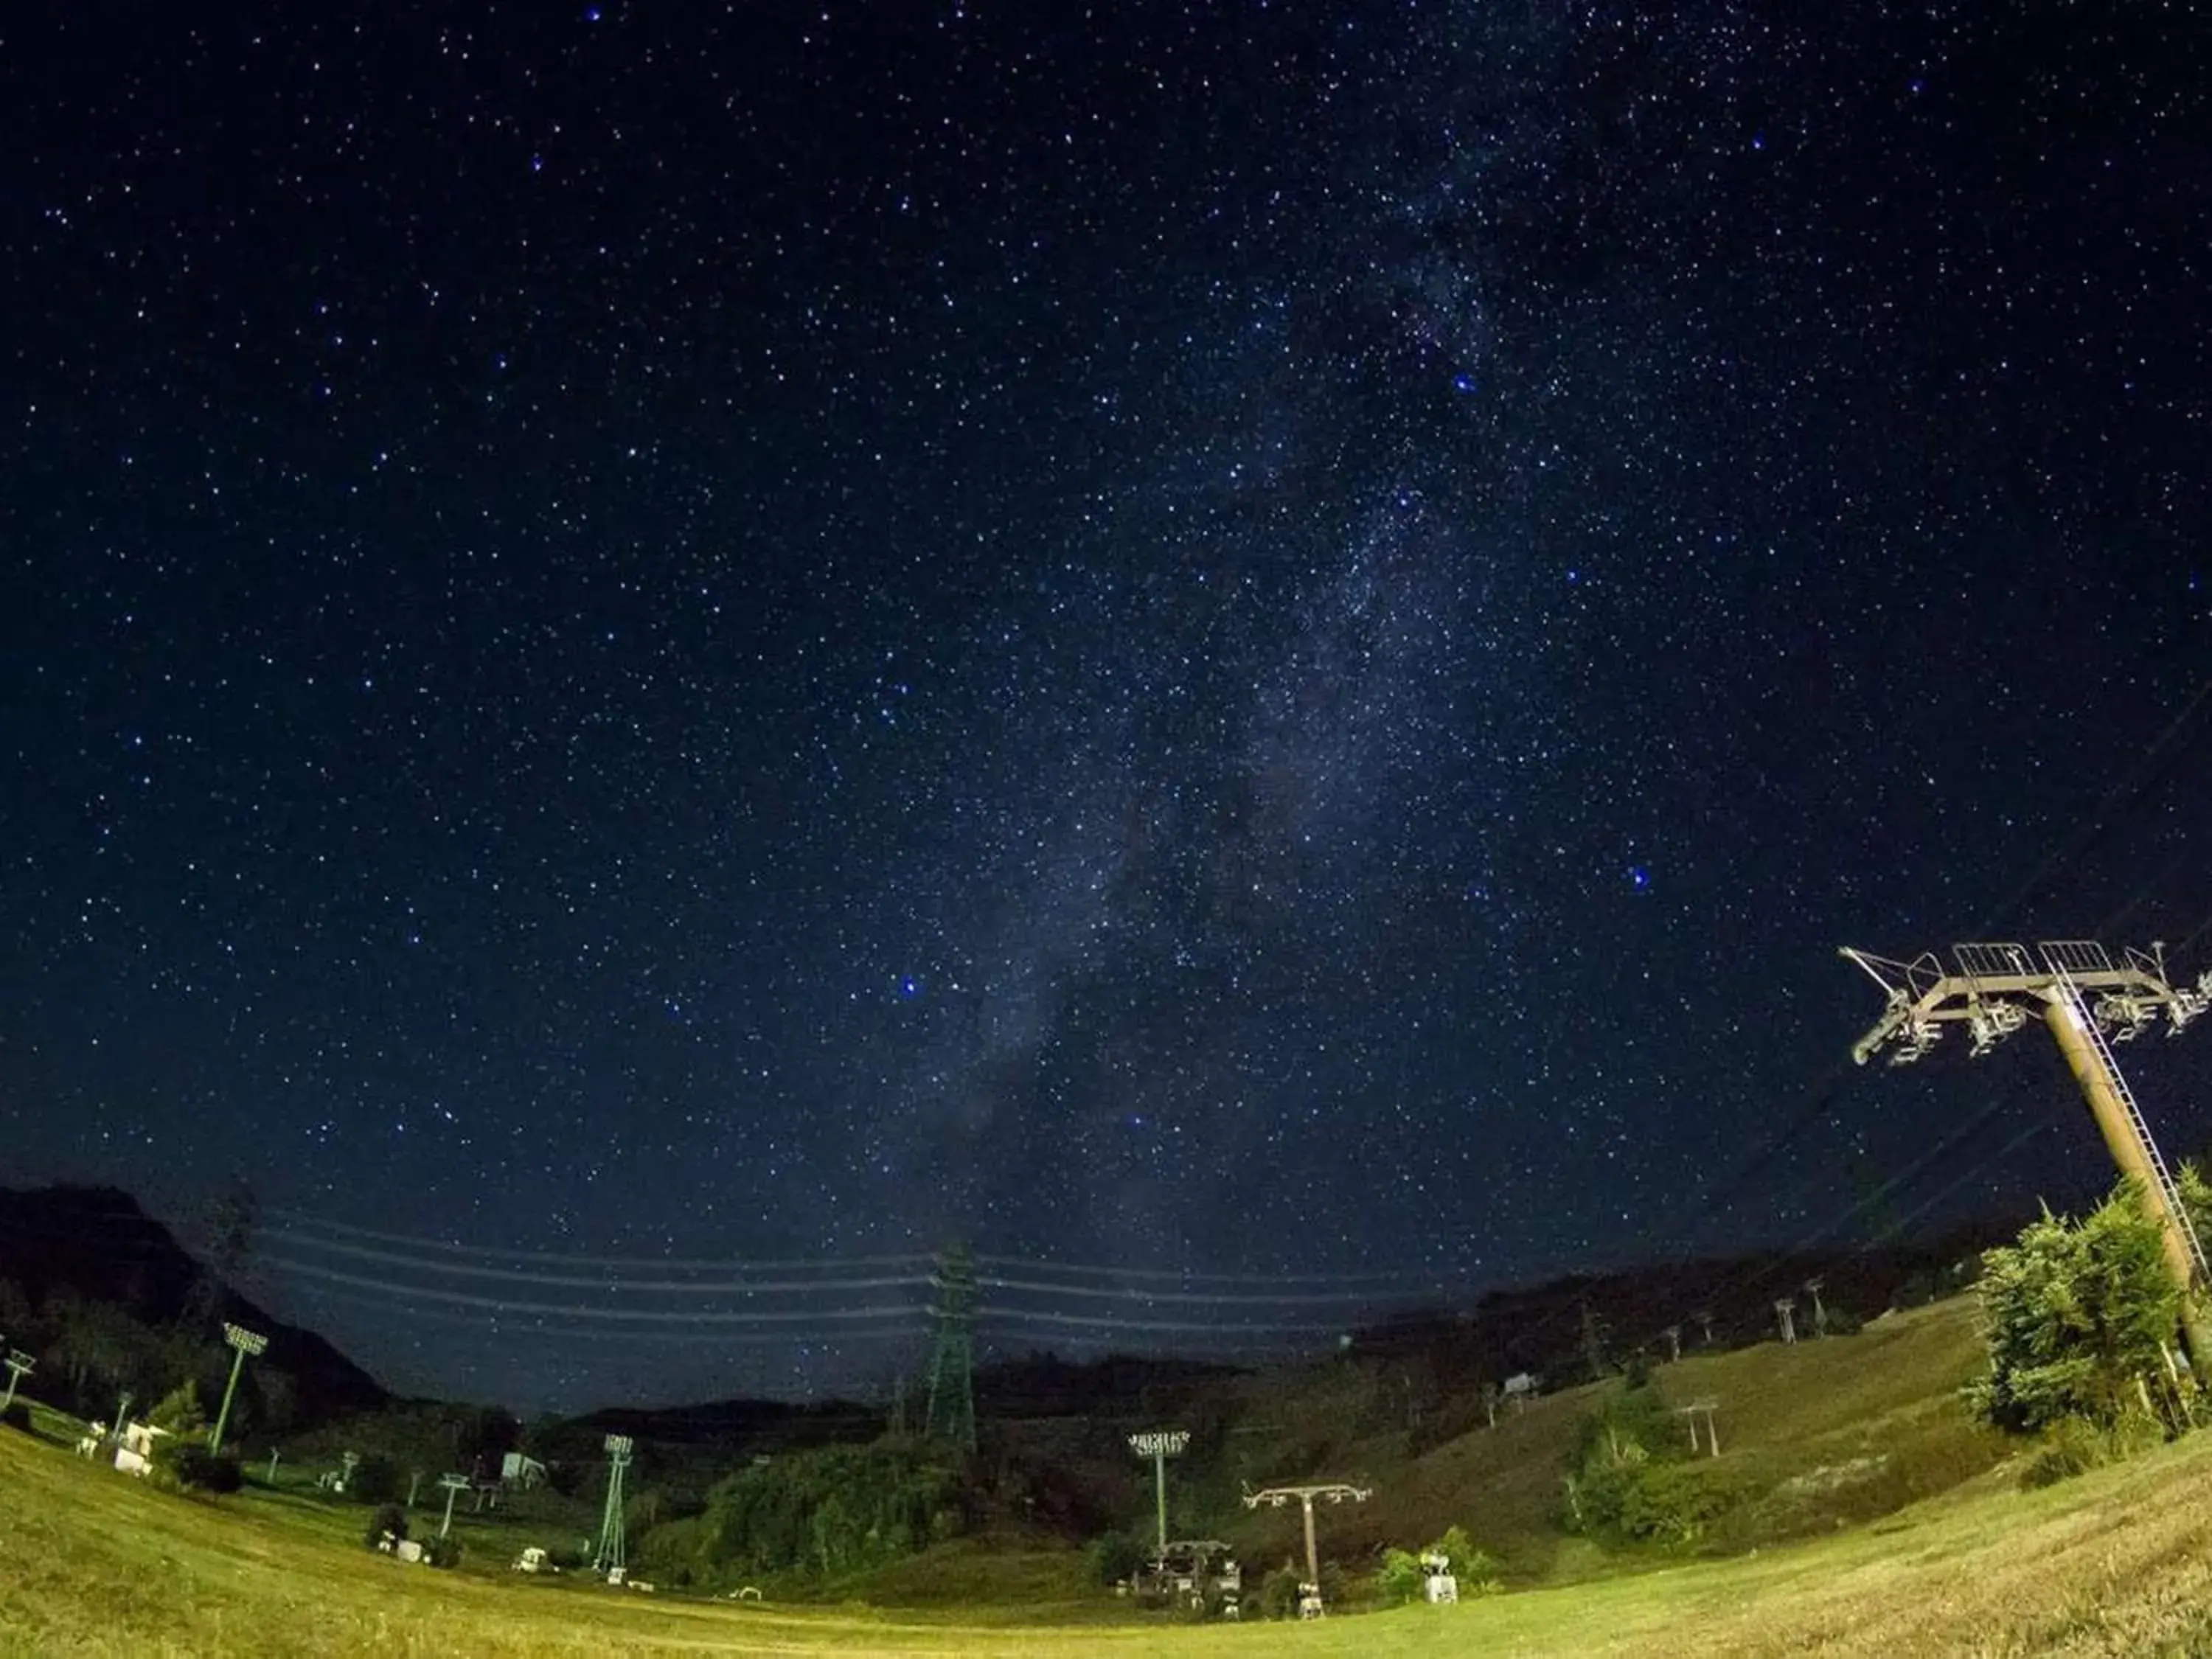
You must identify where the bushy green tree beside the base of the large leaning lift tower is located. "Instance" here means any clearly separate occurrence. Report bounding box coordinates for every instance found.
[1969,1181,2181,1433]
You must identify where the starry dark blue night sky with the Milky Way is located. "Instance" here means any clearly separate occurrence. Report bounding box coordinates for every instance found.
[0,0,2212,1405]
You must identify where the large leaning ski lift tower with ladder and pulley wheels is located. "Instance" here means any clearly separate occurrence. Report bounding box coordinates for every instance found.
[1843,940,2212,1376]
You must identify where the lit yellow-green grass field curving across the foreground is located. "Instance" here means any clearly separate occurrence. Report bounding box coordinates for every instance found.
[13,1358,2212,1657]
